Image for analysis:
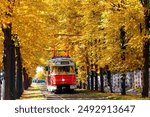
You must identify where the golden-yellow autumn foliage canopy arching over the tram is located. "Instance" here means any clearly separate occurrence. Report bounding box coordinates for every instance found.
[0,0,149,79]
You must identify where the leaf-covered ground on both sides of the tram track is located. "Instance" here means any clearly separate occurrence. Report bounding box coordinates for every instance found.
[19,83,150,100]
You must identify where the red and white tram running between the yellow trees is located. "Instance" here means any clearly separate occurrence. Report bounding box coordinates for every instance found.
[46,56,76,92]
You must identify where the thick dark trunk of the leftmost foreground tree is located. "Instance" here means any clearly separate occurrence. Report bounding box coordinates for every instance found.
[2,24,15,100]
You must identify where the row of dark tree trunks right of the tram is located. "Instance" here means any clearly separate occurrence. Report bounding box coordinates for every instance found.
[83,0,150,97]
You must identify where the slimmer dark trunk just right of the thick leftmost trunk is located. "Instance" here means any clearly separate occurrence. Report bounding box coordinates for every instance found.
[16,47,23,98]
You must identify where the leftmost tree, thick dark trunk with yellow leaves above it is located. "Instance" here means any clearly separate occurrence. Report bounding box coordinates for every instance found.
[1,0,16,100]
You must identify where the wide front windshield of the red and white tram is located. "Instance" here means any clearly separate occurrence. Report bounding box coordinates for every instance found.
[51,66,75,74]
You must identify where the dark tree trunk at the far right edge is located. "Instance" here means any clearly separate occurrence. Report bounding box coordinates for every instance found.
[142,41,149,97]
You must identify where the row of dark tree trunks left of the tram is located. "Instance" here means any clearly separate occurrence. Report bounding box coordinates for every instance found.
[2,23,31,100]
